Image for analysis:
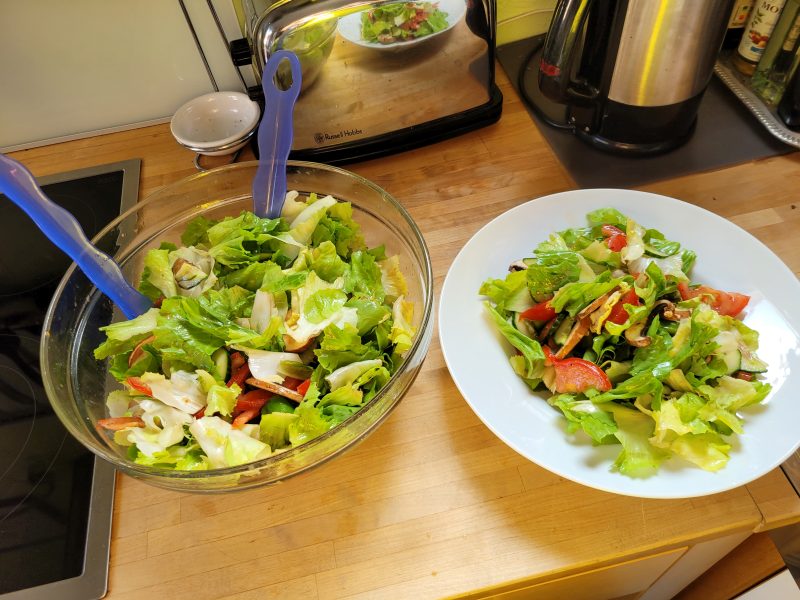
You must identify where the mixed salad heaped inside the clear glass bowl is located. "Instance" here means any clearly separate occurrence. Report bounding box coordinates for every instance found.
[94,192,414,470]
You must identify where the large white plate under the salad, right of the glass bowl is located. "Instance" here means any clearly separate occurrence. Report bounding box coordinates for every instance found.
[439,189,800,498]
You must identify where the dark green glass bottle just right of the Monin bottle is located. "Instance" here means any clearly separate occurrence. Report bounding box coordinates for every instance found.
[750,0,800,105]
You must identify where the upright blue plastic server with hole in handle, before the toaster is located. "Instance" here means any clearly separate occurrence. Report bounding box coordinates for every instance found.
[253,50,302,219]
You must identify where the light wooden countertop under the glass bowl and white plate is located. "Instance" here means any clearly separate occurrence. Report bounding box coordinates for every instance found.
[13,72,800,600]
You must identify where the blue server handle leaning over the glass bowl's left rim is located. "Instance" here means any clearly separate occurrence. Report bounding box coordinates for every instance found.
[0,154,152,319]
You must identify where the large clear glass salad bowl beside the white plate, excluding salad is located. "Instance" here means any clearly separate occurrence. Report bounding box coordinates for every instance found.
[41,161,433,492]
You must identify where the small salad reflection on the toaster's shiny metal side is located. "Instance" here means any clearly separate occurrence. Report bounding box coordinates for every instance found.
[361,2,448,44]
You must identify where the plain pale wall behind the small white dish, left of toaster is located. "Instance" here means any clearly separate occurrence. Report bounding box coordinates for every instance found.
[0,0,250,152]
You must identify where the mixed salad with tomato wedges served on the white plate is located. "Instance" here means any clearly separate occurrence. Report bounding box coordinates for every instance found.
[480,208,770,477]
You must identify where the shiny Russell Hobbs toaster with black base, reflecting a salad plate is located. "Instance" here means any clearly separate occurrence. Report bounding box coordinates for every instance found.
[230,0,503,164]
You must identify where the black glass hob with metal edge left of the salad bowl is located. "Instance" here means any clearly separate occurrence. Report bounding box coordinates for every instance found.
[0,159,141,600]
